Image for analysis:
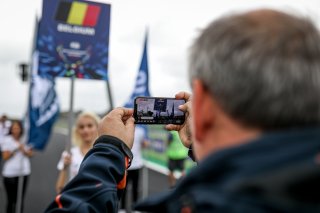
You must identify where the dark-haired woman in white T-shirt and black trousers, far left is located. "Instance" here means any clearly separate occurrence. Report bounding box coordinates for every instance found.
[2,121,33,213]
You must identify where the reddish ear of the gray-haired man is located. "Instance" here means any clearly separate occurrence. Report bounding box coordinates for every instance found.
[192,79,215,143]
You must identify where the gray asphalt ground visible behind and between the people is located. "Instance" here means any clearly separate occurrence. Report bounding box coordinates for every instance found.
[0,129,169,213]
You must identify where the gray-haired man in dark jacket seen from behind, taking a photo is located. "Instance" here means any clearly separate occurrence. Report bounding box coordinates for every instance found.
[45,9,320,212]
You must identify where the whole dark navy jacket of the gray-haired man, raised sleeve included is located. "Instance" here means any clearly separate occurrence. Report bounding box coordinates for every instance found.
[47,129,320,213]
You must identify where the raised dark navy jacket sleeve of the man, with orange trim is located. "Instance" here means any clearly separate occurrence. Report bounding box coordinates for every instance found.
[46,136,126,213]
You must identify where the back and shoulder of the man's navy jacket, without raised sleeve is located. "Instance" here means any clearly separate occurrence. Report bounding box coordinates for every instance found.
[135,129,320,213]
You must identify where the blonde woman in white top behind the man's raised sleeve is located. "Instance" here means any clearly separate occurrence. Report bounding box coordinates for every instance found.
[56,112,100,193]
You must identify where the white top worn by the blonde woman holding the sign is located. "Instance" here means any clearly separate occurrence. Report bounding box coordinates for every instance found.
[57,146,84,181]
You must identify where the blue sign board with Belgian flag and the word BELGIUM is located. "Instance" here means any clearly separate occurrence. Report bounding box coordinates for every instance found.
[37,0,111,80]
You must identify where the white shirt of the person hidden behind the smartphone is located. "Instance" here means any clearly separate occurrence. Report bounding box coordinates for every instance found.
[129,126,145,170]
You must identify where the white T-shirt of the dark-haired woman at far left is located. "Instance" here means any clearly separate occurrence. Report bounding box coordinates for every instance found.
[1,135,31,177]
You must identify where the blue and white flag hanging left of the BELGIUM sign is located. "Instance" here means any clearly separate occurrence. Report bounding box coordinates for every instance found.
[27,51,59,150]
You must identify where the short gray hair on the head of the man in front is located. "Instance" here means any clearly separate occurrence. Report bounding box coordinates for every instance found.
[189,10,320,130]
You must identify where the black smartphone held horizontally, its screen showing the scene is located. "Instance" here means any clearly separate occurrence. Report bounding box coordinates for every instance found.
[133,97,186,125]
